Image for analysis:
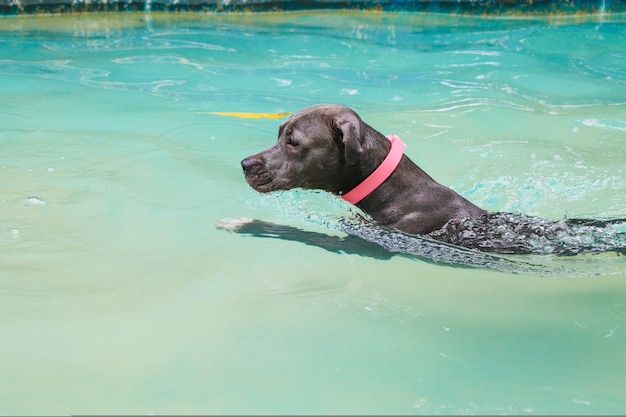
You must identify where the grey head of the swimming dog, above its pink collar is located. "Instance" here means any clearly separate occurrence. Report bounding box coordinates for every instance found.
[241,104,387,193]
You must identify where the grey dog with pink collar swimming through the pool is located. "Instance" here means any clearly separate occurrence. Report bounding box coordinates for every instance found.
[241,104,626,255]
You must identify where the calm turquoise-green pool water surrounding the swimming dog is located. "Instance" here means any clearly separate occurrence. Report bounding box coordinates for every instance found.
[0,12,626,414]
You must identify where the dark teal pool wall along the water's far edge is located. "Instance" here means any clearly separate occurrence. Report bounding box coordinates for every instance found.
[0,0,626,15]
